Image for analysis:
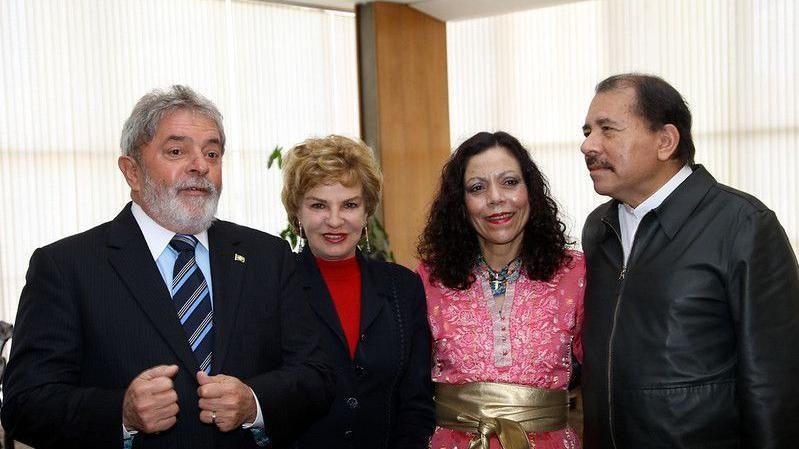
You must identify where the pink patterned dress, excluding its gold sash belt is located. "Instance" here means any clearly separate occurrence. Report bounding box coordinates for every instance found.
[417,251,585,449]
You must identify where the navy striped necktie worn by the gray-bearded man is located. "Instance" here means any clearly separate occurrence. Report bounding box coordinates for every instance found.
[169,234,214,373]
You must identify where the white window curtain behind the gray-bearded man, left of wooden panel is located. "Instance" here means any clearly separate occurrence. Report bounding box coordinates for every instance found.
[0,0,360,321]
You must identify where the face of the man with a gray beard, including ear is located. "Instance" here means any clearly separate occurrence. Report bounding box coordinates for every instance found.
[120,109,222,234]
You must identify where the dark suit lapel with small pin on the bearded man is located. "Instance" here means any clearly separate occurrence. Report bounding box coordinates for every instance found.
[208,224,247,374]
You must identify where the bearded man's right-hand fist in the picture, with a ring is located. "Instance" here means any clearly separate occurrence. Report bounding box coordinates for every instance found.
[197,371,258,432]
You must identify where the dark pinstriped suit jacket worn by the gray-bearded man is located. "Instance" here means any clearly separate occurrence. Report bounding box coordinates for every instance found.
[2,204,332,449]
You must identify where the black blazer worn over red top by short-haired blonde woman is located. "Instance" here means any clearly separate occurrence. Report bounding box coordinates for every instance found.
[298,247,435,449]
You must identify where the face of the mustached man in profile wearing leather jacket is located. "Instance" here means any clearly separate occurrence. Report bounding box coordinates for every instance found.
[580,87,667,207]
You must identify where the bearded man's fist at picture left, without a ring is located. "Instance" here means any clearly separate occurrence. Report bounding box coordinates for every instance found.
[122,365,179,433]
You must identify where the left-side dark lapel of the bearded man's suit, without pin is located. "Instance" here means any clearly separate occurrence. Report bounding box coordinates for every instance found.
[108,203,199,372]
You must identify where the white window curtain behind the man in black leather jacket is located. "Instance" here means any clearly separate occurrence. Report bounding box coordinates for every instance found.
[447,0,799,250]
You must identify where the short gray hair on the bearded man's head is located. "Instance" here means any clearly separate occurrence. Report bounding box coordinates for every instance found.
[120,84,225,162]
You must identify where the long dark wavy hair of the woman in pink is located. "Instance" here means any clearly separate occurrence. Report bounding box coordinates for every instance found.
[417,131,571,290]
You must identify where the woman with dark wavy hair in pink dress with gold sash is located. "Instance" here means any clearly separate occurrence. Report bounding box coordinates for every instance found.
[417,132,585,449]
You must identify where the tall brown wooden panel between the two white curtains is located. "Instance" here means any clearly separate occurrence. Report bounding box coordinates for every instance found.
[358,2,450,267]
